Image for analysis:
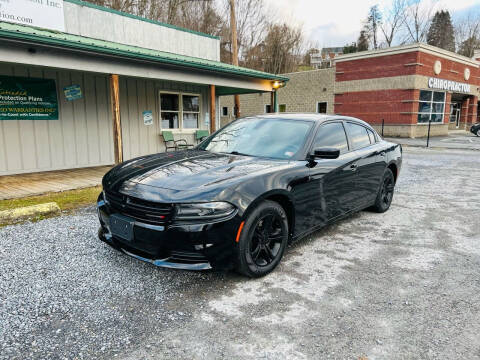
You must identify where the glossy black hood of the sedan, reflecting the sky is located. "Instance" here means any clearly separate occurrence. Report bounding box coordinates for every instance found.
[104,150,288,191]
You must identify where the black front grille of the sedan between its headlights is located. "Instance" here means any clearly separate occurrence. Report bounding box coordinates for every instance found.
[105,192,173,225]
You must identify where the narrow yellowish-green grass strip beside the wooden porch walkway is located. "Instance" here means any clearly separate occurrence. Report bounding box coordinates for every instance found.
[0,186,102,211]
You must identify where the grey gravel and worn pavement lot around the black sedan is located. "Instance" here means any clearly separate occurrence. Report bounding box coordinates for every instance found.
[0,148,480,360]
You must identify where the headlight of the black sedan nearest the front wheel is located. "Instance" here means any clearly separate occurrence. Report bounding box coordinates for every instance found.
[175,201,235,220]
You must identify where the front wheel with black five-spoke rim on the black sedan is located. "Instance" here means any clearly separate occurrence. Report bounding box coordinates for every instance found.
[237,201,288,278]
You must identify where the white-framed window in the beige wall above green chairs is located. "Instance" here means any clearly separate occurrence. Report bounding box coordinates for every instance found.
[160,93,200,129]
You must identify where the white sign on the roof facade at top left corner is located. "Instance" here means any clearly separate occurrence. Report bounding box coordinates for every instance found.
[0,0,65,31]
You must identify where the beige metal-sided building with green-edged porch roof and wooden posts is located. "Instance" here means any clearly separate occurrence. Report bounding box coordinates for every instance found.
[0,0,288,175]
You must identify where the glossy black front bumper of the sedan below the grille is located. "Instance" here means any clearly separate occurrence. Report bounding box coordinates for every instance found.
[97,196,240,270]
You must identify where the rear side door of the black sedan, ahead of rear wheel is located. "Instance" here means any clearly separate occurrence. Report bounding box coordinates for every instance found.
[345,121,383,208]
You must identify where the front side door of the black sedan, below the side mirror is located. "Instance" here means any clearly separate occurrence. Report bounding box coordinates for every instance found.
[310,121,357,226]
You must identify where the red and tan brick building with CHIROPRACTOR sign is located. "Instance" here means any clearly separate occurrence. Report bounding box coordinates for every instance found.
[220,44,480,137]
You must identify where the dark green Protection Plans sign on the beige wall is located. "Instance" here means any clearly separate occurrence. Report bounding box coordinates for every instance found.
[0,76,58,120]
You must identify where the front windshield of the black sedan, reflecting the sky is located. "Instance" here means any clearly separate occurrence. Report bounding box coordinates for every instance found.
[200,118,313,159]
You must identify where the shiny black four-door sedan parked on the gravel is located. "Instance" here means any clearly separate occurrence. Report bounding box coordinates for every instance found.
[98,114,402,277]
